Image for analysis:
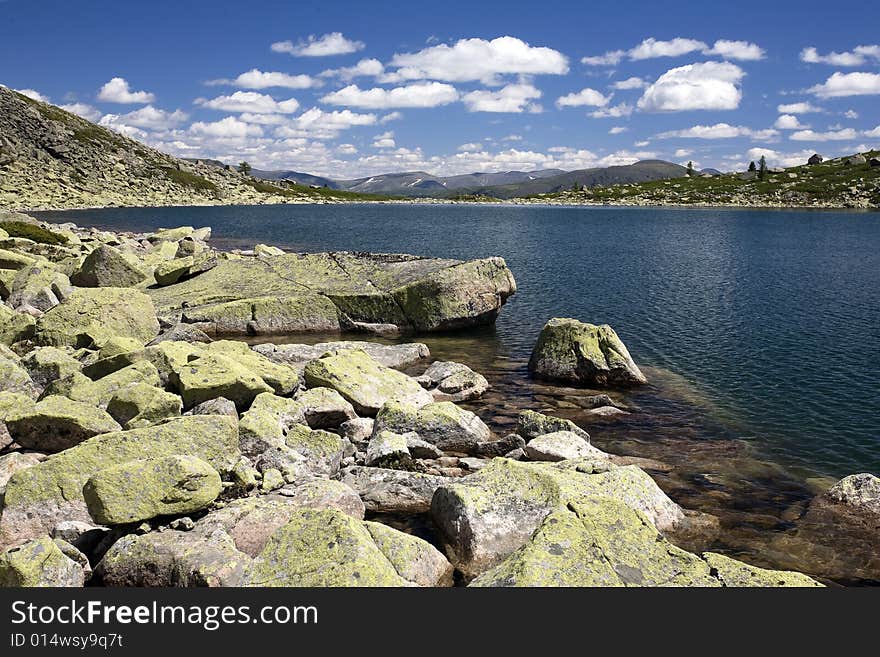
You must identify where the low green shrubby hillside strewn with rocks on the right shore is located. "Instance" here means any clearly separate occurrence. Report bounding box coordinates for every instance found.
[525,151,880,208]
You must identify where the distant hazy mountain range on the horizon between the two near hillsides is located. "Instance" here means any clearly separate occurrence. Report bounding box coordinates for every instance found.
[244,160,687,199]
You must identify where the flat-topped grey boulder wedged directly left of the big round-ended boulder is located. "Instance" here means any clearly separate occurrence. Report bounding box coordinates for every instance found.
[342,466,449,514]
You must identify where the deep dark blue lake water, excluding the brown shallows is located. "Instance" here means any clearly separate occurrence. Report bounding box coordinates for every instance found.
[37,205,880,477]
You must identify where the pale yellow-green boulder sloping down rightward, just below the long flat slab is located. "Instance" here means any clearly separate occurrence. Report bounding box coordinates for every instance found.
[303,350,433,416]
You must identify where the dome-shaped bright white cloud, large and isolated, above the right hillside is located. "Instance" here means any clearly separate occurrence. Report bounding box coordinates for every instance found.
[638,62,745,112]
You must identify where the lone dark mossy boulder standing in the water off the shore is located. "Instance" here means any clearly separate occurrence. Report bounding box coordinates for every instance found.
[529,318,647,386]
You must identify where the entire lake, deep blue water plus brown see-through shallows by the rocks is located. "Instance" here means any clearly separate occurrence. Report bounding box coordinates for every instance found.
[41,204,880,580]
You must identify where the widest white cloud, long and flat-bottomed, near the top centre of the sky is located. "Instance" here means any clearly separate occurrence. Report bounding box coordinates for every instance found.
[387,36,568,84]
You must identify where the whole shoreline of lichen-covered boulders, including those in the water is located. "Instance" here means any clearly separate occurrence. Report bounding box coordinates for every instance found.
[0,213,880,586]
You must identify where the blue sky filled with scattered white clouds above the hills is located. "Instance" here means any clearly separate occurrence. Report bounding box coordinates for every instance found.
[0,0,880,179]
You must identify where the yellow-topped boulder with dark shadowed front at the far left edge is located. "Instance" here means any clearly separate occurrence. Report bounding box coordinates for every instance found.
[6,395,122,452]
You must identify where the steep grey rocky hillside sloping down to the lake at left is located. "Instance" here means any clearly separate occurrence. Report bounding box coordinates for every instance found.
[0,87,384,209]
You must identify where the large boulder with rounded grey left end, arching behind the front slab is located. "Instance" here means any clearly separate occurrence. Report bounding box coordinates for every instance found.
[431,458,684,575]
